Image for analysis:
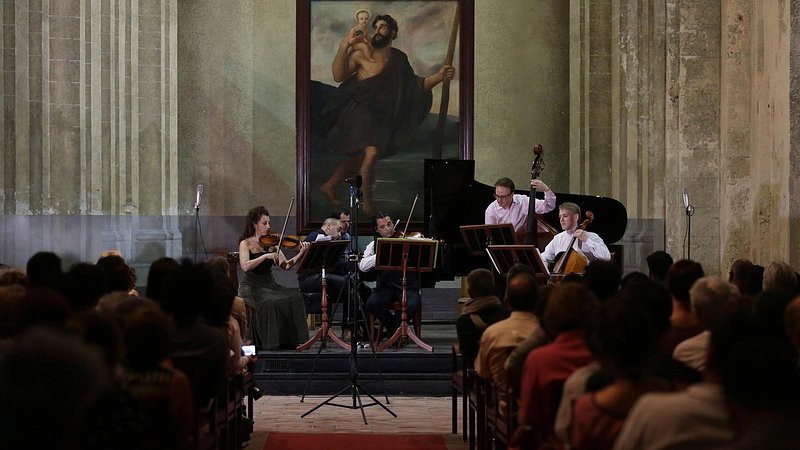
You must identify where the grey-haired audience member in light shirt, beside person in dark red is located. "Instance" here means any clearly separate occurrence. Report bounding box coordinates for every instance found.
[672,277,740,372]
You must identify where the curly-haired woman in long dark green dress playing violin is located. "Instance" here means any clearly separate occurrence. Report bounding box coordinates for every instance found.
[239,206,309,350]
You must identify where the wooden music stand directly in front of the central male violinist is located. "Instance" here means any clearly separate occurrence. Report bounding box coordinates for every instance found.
[375,238,439,352]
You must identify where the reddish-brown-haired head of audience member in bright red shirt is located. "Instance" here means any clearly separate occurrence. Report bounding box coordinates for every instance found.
[544,282,597,336]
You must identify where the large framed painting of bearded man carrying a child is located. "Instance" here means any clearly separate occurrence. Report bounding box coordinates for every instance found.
[297,0,474,233]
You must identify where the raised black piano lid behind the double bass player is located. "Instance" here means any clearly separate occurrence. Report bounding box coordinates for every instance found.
[424,159,628,253]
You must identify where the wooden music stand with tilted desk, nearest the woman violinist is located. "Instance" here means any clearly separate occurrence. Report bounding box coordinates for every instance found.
[297,241,350,352]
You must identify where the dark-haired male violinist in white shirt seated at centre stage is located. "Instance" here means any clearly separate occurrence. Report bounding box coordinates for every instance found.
[358,212,421,335]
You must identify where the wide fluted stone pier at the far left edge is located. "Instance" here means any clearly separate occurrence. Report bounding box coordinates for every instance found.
[0,0,180,268]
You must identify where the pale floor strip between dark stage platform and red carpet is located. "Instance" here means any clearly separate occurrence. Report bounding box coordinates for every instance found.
[248,396,466,450]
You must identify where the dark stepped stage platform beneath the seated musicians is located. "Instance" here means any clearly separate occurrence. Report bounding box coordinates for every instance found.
[254,287,460,397]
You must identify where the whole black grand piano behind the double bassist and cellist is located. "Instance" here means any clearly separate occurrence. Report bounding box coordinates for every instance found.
[424,159,628,281]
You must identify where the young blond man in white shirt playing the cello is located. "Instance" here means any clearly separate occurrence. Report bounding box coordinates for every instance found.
[542,202,611,267]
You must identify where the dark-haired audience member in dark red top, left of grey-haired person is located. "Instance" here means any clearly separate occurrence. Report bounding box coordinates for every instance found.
[661,259,704,355]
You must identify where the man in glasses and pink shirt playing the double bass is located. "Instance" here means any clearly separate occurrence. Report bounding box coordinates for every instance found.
[484,178,556,233]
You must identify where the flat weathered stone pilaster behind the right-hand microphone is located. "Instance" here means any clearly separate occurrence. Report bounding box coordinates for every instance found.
[664,0,720,273]
